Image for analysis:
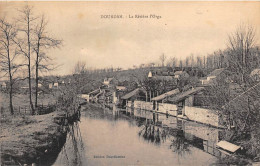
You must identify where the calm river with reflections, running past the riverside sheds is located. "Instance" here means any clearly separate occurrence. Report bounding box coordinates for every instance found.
[53,107,230,166]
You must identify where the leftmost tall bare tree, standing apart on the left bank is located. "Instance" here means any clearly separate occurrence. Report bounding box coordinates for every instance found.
[0,19,19,115]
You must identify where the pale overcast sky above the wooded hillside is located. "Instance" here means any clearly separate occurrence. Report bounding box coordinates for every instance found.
[0,2,260,75]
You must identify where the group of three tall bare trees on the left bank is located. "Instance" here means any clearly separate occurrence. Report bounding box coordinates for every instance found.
[0,5,62,115]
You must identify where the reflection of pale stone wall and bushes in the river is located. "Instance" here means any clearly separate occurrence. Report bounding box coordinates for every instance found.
[132,107,225,157]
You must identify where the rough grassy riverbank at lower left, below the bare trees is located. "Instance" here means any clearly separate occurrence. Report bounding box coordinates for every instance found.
[0,111,72,165]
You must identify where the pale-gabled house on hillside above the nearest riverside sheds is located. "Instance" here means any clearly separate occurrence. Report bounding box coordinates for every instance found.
[200,68,226,85]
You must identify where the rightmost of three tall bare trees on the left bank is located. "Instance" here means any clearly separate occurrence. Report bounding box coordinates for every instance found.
[33,15,61,108]
